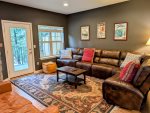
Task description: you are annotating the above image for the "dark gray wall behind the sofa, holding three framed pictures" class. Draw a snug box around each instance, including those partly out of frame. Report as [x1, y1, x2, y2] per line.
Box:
[68, 0, 150, 51]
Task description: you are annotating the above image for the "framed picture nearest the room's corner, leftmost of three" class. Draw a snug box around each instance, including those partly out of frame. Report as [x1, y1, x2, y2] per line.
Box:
[81, 26, 90, 40]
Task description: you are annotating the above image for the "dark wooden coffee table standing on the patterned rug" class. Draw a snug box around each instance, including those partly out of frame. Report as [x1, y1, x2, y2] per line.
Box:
[57, 66, 87, 89]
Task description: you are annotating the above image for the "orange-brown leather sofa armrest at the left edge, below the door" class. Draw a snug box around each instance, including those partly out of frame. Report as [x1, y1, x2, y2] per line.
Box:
[0, 82, 12, 94]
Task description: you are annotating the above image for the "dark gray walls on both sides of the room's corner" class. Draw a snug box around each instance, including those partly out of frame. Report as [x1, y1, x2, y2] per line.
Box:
[0, 0, 150, 78]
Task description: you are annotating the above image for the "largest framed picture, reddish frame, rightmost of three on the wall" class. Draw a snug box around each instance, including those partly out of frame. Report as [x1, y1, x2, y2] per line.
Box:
[114, 22, 128, 41]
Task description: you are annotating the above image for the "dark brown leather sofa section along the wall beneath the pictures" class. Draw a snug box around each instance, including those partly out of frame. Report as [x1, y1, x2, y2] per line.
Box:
[57, 48, 125, 79]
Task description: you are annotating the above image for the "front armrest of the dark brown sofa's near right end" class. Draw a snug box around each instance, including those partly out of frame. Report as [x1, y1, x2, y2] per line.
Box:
[102, 75, 144, 110]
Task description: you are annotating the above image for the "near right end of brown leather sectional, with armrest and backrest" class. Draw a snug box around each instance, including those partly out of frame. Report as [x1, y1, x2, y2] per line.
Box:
[102, 59, 150, 110]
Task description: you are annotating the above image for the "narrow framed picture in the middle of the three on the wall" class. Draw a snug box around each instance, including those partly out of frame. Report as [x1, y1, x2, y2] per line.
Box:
[97, 22, 106, 39]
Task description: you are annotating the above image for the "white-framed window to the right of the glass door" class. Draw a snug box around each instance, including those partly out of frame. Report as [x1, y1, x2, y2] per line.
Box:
[38, 25, 64, 58]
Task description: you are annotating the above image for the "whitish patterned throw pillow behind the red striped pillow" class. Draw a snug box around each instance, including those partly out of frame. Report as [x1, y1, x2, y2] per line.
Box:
[120, 53, 142, 68]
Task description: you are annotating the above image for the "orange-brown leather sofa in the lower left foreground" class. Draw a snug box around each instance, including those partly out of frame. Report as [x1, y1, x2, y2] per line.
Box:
[0, 82, 59, 113]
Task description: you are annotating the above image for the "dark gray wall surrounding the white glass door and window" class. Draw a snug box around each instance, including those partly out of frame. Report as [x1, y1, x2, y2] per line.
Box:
[0, 2, 67, 79]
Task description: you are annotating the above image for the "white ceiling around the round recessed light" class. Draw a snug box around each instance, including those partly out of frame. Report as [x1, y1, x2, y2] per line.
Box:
[0, 0, 128, 14]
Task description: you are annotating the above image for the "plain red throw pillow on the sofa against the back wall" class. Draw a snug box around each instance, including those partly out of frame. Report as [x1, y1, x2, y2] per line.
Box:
[82, 48, 95, 62]
